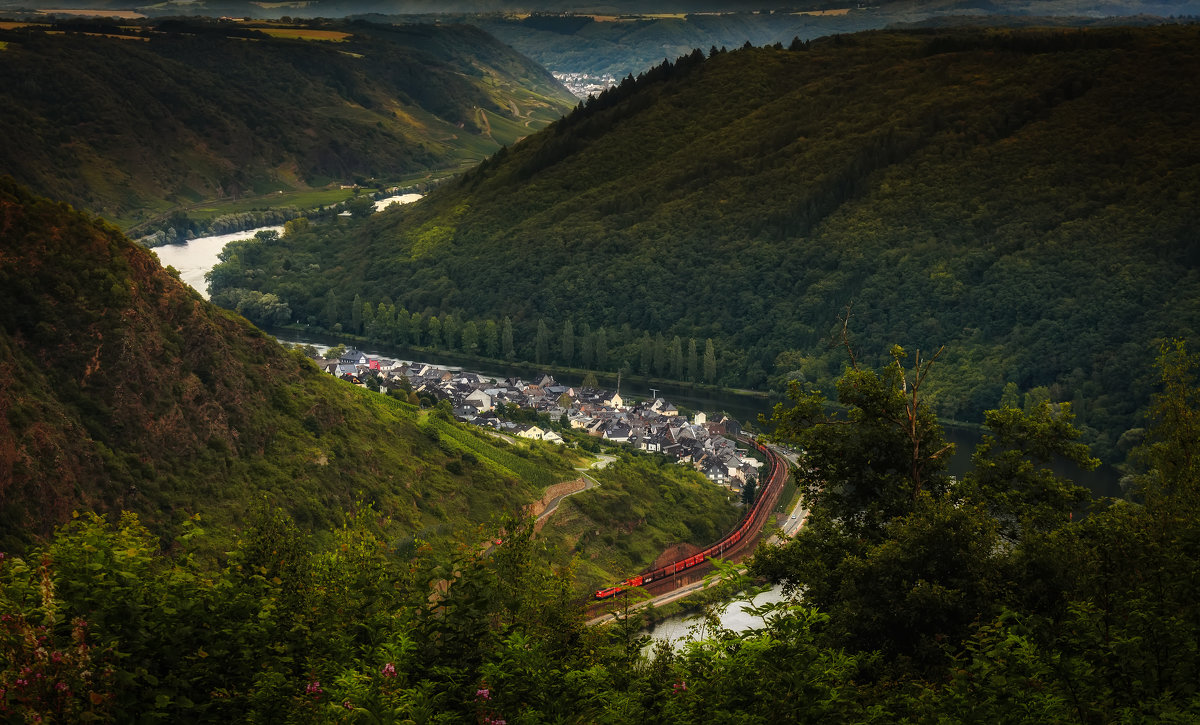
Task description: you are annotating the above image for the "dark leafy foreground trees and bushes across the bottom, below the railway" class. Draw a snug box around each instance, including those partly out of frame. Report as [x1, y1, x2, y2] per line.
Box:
[0, 343, 1200, 725]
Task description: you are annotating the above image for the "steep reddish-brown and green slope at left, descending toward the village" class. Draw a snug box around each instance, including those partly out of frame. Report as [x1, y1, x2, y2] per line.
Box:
[0, 179, 585, 550]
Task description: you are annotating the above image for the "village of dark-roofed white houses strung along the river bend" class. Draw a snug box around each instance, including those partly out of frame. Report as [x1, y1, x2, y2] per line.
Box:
[316, 348, 762, 493]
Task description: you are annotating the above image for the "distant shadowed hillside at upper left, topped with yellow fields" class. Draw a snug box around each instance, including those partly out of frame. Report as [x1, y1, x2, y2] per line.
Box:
[0, 19, 574, 222]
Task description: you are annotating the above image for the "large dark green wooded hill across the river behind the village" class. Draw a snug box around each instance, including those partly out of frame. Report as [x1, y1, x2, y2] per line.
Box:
[217, 26, 1200, 457]
